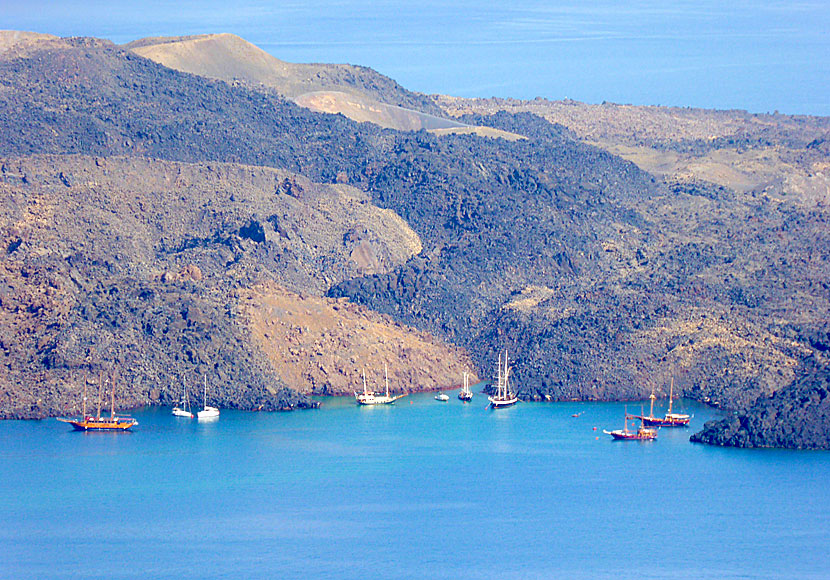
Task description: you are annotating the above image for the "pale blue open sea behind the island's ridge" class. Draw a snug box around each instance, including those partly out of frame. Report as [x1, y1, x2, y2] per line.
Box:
[8, 0, 830, 115]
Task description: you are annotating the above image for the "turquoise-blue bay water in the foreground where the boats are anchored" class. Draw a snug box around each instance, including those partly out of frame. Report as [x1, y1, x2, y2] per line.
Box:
[0, 392, 830, 580]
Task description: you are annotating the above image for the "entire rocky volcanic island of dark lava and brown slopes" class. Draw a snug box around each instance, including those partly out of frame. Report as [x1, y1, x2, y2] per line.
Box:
[0, 33, 830, 448]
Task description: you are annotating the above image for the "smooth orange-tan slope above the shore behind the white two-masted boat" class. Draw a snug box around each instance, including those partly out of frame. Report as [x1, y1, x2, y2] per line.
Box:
[239, 283, 476, 395]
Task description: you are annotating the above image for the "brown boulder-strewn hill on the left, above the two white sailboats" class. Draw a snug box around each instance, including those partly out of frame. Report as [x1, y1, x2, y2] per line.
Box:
[0, 155, 448, 417]
